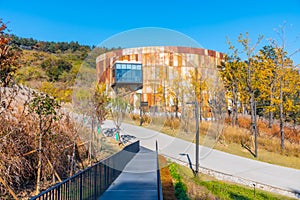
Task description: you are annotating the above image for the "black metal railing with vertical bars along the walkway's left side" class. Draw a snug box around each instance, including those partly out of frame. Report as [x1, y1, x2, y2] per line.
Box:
[31, 141, 140, 200]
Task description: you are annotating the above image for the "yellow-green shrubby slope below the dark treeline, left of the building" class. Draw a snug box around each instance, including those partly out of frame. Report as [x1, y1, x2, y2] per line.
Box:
[15, 50, 86, 102]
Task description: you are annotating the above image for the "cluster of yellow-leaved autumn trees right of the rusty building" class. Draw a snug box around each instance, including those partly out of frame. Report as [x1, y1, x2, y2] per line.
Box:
[219, 29, 300, 153]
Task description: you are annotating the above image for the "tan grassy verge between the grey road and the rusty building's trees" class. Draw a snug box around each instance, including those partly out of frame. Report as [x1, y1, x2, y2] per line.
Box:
[125, 115, 300, 169]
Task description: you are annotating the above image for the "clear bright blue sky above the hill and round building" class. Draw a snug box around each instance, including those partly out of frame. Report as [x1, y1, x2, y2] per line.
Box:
[0, 0, 300, 64]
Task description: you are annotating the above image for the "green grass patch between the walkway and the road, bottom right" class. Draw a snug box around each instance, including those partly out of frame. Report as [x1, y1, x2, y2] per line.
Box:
[164, 159, 298, 200]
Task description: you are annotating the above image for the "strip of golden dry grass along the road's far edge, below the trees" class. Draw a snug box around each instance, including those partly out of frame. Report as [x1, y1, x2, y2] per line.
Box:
[127, 113, 300, 169]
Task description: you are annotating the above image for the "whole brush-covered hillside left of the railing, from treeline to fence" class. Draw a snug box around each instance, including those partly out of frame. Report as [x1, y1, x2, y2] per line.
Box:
[0, 29, 120, 199]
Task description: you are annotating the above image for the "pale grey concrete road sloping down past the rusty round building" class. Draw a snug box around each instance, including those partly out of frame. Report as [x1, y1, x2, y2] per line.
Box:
[103, 121, 300, 198]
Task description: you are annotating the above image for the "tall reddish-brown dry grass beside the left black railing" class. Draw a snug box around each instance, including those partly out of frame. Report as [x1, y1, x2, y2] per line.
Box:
[0, 88, 118, 199]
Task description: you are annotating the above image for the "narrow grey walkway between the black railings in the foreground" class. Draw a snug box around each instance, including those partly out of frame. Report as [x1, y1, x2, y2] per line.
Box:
[100, 147, 158, 200]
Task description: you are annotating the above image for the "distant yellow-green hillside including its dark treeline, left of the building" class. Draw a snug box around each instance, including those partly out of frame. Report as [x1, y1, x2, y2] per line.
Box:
[7, 35, 117, 102]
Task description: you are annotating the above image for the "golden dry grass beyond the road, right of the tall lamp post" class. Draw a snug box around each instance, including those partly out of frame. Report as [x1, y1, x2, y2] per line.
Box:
[200, 124, 300, 169]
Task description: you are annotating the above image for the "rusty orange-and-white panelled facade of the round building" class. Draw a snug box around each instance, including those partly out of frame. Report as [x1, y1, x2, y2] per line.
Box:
[96, 46, 224, 115]
